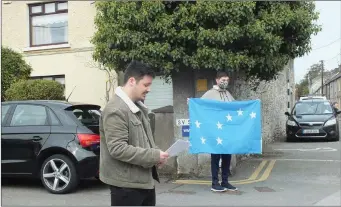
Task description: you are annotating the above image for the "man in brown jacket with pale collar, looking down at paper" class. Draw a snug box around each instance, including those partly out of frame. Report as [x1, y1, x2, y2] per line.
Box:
[100, 61, 168, 206]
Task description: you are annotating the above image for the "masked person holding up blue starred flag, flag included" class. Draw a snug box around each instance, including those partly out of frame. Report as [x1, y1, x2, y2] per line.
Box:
[188, 72, 262, 192]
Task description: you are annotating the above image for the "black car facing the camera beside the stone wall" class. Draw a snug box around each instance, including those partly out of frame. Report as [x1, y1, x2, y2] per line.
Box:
[285, 99, 341, 141]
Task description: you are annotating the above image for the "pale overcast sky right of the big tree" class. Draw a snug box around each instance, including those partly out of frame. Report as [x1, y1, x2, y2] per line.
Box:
[294, 1, 341, 83]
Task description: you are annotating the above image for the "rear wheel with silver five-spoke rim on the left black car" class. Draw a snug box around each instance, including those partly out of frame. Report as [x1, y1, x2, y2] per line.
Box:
[40, 154, 79, 194]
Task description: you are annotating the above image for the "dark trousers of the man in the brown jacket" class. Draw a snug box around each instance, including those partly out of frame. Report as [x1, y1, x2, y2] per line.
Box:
[110, 186, 156, 206]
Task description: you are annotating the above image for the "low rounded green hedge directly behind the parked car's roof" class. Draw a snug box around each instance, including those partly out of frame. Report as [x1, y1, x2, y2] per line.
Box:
[6, 80, 65, 101]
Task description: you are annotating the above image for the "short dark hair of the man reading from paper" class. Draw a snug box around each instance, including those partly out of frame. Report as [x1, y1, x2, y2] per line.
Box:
[124, 60, 155, 84]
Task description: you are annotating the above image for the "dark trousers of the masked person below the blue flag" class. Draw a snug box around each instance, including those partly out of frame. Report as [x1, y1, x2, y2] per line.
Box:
[211, 154, 231, 185]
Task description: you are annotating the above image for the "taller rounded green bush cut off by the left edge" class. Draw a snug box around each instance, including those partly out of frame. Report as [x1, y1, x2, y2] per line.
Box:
[1, 46, 32, 101]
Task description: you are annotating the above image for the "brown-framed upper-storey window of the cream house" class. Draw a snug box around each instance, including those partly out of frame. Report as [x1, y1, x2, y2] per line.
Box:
[29, 2, 68, 47]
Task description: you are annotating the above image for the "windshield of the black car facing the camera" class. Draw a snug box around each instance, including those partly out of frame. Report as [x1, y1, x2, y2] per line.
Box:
[293, 102, 333, 115]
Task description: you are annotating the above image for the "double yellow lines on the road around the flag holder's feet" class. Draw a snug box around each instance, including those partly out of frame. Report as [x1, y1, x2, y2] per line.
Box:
[173, 160, 276, 185]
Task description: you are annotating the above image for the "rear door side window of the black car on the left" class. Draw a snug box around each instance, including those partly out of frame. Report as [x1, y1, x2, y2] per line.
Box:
[10, 105, 48, 126]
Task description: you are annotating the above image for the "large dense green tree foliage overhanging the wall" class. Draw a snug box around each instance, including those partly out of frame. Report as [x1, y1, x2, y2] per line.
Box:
[92, 1, 320, 80]
